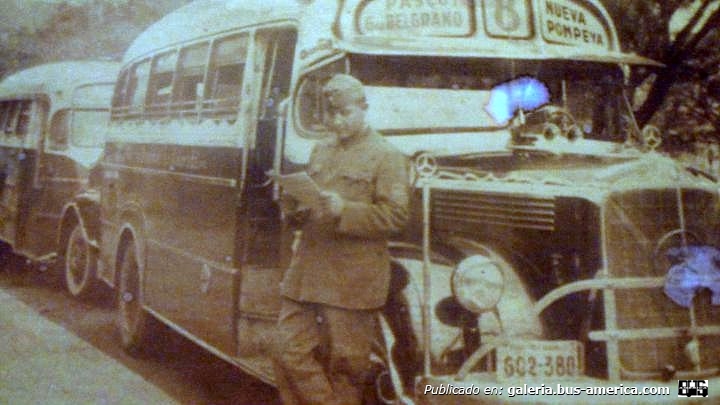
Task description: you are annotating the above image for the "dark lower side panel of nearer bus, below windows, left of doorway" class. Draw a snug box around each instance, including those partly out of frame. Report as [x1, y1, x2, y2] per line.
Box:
[103, 142, 242, 352]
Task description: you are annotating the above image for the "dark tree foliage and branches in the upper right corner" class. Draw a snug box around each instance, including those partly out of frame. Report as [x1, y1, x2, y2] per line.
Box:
[607, 0, 720, 148]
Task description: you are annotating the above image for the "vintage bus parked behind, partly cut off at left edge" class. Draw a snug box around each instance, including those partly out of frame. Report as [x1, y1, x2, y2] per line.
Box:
[0, 61, 120, 296]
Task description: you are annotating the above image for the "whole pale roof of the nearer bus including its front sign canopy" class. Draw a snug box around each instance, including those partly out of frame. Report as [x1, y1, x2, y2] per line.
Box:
[123, 0, 660, 65]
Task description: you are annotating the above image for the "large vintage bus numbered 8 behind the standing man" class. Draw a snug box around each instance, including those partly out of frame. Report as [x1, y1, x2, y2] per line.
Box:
[100, 0, 720, 403]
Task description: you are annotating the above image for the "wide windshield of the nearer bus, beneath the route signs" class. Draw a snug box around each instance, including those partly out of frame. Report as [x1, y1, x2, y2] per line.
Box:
[292, 55, 629, 142]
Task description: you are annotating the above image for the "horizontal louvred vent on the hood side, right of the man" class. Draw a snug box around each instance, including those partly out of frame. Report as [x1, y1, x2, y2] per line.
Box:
[432, 190, 555, 231]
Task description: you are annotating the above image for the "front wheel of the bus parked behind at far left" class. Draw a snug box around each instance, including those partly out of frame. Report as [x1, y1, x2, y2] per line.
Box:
[63, 224, 98, 298]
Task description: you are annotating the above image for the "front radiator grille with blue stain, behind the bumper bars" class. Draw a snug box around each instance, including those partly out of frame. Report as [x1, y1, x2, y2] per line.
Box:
[606, 190, 720, 372]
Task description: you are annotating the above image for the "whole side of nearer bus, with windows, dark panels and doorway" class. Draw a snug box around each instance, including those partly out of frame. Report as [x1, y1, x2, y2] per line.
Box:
[100, 16, 296, 370]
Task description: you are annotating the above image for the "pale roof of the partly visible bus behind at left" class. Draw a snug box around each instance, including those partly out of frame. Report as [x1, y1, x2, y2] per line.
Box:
[0, 61, 120, 98]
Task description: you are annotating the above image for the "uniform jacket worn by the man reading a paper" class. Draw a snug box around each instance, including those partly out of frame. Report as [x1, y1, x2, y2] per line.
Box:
[281, 129, 408, 309]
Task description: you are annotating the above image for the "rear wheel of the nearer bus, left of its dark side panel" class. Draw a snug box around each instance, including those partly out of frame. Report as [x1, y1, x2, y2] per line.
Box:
[117, 243, 153, 355]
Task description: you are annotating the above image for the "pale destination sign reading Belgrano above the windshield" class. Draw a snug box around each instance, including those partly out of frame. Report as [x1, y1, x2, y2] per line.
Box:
[356, 0, 475, 37]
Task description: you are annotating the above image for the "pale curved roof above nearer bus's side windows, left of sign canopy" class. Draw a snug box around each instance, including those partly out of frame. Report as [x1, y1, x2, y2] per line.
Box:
[123, 0, 302, 63]
